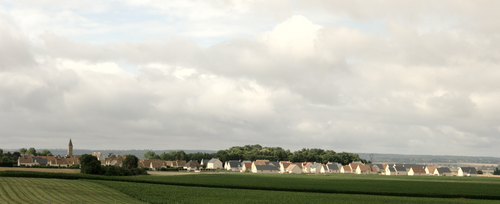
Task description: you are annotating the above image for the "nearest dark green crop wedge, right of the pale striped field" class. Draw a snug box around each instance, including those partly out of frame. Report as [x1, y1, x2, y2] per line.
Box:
[92, 180, 499, 204]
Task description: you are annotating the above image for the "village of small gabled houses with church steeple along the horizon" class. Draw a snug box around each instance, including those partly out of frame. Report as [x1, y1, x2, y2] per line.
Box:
[15, 140, 477, 176]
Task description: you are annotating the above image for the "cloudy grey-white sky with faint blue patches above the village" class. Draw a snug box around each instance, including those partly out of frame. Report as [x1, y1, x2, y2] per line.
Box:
[0, 0, 500, 157]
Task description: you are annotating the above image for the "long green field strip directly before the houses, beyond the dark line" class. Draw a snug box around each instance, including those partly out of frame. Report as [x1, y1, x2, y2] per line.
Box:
[102, 174, 500, 200]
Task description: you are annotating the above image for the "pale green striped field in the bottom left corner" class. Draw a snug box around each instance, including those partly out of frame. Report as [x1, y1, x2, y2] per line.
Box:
[0, 177, 144, 204]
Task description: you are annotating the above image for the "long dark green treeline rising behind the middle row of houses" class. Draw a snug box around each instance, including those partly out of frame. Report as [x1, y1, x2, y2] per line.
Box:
[144, 144, 367, 165]
